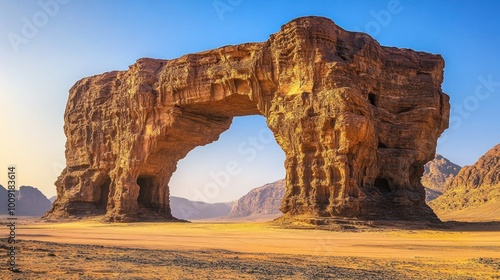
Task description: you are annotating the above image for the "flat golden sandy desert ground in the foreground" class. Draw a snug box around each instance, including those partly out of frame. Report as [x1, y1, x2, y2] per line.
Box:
[0, 221, 500, 279]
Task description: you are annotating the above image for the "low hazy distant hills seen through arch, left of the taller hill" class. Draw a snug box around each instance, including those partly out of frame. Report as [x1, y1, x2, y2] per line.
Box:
[170, 196, 233, 220]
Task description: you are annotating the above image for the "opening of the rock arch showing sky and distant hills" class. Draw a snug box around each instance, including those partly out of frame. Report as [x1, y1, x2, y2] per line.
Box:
[169, 115, 285, 220]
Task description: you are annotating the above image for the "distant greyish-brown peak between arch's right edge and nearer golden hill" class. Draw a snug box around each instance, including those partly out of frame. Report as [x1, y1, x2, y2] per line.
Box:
[420, 154, 461, 201]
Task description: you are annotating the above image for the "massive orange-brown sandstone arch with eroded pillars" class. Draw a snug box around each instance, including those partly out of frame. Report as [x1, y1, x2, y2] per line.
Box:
[47, 17, 449, 221]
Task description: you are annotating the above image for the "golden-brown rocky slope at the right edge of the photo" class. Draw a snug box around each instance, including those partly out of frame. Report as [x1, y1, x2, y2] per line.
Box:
[430, 145, 500, 220]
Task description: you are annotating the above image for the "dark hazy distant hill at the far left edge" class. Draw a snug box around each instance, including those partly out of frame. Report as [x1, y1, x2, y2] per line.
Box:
[0, 185, 52, 216]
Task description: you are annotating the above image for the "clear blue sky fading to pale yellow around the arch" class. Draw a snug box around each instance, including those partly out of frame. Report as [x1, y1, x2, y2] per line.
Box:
[0, 0, 500, 202]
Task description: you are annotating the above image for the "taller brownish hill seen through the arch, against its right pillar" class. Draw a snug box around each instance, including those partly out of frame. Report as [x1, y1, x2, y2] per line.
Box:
[227, 180, 285, 218]
